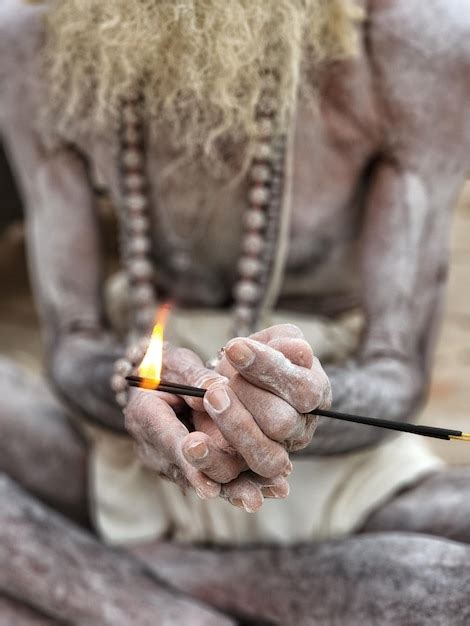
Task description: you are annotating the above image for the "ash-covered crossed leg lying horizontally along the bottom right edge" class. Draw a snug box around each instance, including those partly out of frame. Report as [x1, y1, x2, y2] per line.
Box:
[134, 533, 470, 626]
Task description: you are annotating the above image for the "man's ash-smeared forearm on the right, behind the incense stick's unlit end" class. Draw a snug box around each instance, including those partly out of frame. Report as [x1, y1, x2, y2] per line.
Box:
[309, 161, 452, 454]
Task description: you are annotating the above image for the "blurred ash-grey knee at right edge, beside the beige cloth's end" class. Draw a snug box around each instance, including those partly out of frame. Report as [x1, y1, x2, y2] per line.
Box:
[361, 467, 470, 544]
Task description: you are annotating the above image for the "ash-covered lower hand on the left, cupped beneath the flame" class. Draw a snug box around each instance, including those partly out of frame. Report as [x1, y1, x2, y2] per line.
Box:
[124, 343, 252, 499]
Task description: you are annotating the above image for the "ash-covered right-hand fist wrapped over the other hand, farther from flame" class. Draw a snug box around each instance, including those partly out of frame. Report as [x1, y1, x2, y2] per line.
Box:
[198, 324, 331, 492]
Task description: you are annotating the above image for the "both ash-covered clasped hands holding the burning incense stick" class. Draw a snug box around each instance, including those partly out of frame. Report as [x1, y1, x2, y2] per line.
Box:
[125, 324, 331, 512]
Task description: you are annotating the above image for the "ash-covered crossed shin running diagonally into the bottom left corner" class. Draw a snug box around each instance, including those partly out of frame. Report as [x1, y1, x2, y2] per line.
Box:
[0, 476, 233, 626]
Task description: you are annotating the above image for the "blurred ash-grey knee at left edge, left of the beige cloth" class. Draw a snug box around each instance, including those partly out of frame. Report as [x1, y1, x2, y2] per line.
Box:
[0, 358, 87, 521]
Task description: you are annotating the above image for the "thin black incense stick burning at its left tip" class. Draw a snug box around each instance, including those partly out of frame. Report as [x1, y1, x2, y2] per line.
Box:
[126, 376, 470, 441]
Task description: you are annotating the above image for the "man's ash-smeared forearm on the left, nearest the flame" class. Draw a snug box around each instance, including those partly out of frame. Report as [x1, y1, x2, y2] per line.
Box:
[2, 122, 124, 430]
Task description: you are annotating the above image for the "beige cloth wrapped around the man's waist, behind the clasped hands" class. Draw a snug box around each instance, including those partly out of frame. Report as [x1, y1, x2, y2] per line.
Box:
[81, 311, 442, 545]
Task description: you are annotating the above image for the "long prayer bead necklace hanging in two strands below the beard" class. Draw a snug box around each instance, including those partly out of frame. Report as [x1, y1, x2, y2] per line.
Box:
[119, 77, 286, 346]
